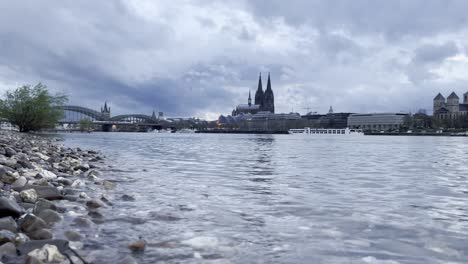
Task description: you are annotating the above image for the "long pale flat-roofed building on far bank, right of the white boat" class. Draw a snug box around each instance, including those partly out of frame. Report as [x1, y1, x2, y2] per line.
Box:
[348, 113, 408, 131]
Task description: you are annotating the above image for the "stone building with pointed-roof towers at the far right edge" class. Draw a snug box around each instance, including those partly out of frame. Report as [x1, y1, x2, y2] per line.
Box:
[433, 92, 468, 119]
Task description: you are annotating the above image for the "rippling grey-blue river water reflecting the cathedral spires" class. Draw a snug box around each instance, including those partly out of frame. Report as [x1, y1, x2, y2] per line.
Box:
[59, 133, 468, 264]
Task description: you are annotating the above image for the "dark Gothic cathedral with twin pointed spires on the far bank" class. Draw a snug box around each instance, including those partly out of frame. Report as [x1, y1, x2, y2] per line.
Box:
[232, 73, 275, 116]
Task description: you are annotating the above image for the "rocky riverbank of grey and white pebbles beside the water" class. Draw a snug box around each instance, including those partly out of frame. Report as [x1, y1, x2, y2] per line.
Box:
[0, 131, 133, 264]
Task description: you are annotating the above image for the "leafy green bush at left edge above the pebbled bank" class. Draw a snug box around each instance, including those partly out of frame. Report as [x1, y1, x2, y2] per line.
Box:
[0, 83, 67, 132]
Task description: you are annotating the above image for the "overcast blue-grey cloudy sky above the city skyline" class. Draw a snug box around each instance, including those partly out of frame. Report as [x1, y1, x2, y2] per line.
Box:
[0, 0, 468, 119]
